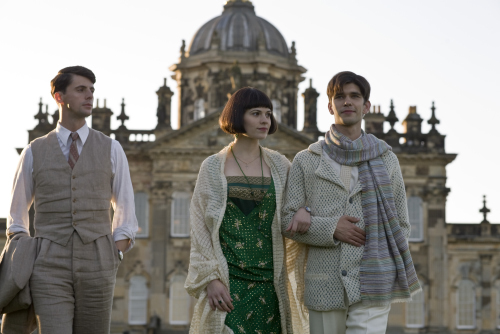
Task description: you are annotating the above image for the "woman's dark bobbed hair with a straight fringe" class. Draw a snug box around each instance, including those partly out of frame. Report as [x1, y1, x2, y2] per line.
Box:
[219, 87, 278, 135]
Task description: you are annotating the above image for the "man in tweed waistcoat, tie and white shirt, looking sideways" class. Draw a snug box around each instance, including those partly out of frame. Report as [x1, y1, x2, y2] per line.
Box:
[7, 66, 137, 334]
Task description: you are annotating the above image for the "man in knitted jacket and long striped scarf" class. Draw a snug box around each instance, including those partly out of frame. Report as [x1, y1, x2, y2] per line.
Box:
[282, 72, 421, 334]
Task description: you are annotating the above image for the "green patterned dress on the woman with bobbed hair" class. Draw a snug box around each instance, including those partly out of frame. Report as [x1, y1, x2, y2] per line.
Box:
[219, 176, 281, 334]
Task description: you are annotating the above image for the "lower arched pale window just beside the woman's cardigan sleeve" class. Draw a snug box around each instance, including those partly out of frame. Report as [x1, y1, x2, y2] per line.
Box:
[169, 275, 191, 325]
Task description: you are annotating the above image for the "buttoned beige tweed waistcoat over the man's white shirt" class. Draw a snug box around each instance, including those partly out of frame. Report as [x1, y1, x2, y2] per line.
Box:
[31, 129, 113, 246]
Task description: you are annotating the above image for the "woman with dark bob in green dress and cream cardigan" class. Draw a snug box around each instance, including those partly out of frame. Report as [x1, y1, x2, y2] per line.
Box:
[185, 87, 308, 334]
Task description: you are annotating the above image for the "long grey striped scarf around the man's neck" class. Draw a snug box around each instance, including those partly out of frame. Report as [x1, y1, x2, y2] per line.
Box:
[322, 125, 421, 305]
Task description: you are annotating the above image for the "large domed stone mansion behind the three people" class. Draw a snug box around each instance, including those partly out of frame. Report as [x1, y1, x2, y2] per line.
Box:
[5, 0, 500, 334]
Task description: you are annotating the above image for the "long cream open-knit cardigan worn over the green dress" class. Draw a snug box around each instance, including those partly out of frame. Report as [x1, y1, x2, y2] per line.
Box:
[185, 146, 309, 334]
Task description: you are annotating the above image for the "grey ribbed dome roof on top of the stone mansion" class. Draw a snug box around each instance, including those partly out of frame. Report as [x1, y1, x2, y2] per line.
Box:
[189, 0, 288, 58]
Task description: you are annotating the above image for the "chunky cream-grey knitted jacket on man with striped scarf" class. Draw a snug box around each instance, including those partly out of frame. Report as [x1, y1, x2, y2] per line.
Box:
[282, 142, 410, 311]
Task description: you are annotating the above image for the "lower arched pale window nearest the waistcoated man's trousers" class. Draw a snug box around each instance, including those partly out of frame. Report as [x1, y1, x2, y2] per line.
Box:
[128, 276, 148, 325]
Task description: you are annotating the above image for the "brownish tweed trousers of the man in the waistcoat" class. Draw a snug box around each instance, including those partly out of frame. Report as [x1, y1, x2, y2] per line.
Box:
[30, 232, 120, 334]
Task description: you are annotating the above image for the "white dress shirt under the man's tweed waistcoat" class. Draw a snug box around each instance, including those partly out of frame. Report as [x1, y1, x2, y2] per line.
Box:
[7, 123, 138, 251]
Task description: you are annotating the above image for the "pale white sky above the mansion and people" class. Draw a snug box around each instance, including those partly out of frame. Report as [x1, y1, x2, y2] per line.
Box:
[0, 0, 500, 223]
